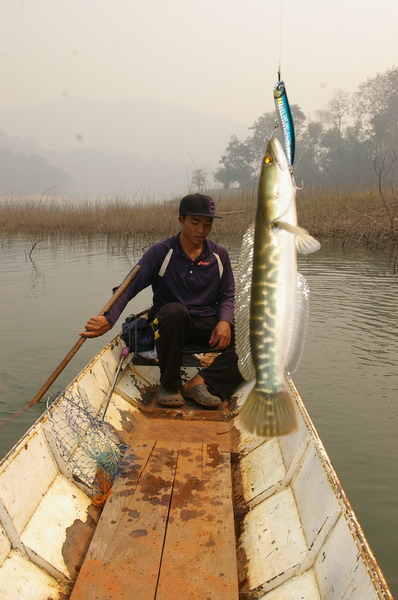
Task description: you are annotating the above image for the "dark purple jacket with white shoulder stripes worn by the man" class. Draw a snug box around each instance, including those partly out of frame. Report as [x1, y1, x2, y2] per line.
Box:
[106, 234, 235, 327]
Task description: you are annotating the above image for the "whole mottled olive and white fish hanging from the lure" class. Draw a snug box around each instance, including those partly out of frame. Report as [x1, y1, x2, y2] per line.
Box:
[235, 136, 320, 437]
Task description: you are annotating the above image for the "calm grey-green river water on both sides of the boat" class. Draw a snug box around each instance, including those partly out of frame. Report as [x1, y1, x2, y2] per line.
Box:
[0, 232, 398, 593]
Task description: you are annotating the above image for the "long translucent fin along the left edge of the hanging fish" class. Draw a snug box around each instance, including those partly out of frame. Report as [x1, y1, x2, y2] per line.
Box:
[235, 223, 256, 381]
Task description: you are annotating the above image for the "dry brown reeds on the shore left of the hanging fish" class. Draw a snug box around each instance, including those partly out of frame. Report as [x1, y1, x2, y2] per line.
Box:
[0, 190, 254, 238]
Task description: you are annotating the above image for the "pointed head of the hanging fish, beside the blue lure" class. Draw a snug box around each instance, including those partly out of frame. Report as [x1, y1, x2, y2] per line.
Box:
[257, 137, 294, 225]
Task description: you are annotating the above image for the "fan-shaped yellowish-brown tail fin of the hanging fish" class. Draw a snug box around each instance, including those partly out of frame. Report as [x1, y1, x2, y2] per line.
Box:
[239, 387, 296, 437]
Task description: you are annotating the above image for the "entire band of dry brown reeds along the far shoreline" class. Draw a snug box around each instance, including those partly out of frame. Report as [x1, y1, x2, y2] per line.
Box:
[0, 188, 398, 252]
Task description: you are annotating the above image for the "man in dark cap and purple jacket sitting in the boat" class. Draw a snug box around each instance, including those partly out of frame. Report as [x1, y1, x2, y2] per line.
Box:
[80, 194, 242, 407]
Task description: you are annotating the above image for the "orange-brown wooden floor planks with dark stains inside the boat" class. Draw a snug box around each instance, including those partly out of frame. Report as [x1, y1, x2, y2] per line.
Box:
[71, 441, 238, 600]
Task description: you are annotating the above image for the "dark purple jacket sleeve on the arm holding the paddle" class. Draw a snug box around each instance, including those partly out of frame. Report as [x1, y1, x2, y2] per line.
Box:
[105, 242, 164, 327]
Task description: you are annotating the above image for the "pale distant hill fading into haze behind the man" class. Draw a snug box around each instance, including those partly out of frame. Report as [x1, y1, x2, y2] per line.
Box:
[0, 97, 247, 195]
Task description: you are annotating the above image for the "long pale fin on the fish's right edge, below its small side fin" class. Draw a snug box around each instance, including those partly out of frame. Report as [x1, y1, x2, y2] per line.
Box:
[286, 273, 310, 373]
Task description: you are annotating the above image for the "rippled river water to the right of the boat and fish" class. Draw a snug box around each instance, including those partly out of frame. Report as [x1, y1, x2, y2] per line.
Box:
[294, 247, 398, 594]
